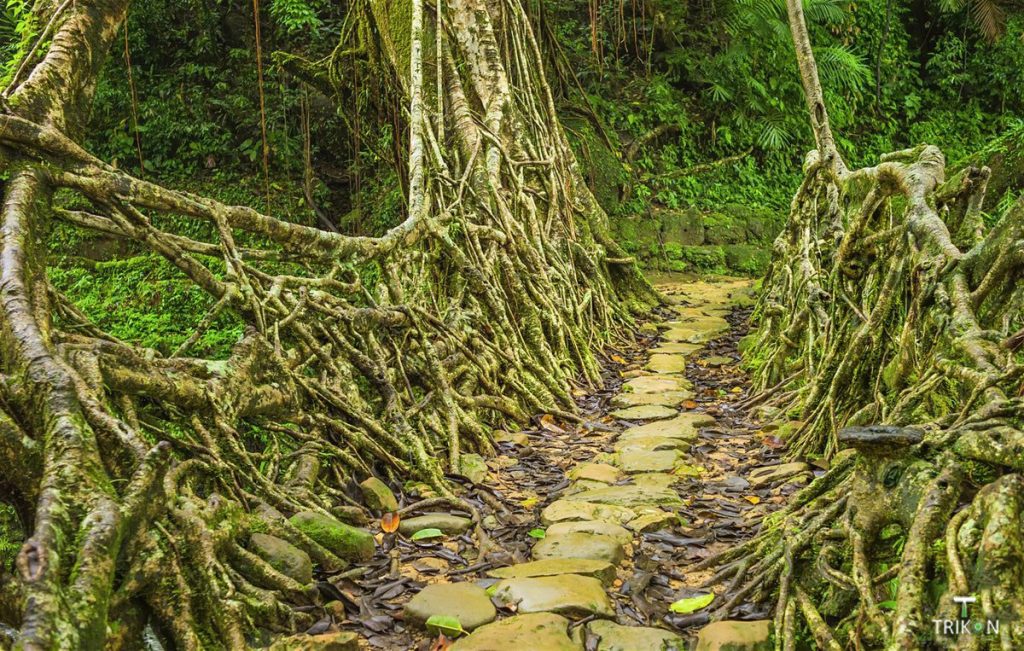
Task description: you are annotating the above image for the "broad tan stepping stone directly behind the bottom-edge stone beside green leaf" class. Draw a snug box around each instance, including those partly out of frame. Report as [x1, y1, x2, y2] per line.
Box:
[493, 574, 615, 618]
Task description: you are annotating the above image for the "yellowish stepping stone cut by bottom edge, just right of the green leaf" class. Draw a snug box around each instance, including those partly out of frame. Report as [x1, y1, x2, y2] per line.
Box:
[451, 612, 583, 651]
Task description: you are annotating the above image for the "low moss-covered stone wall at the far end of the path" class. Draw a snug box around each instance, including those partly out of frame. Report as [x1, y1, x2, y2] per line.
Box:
[612, 204, 785, 275]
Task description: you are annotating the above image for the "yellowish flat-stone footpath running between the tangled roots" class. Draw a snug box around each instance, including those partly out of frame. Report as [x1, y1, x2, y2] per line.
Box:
[406, 280, 768, 651]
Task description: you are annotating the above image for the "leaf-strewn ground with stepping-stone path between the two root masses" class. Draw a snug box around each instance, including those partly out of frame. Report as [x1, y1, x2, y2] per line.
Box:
[301, 275, 820, 651]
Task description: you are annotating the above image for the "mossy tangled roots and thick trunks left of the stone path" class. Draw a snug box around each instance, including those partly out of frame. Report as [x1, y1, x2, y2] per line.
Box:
[0, 0, 655, 649]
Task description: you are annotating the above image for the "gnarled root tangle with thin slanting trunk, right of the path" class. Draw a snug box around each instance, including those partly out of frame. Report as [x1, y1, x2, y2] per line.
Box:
[702, 2, 1024, 649]
